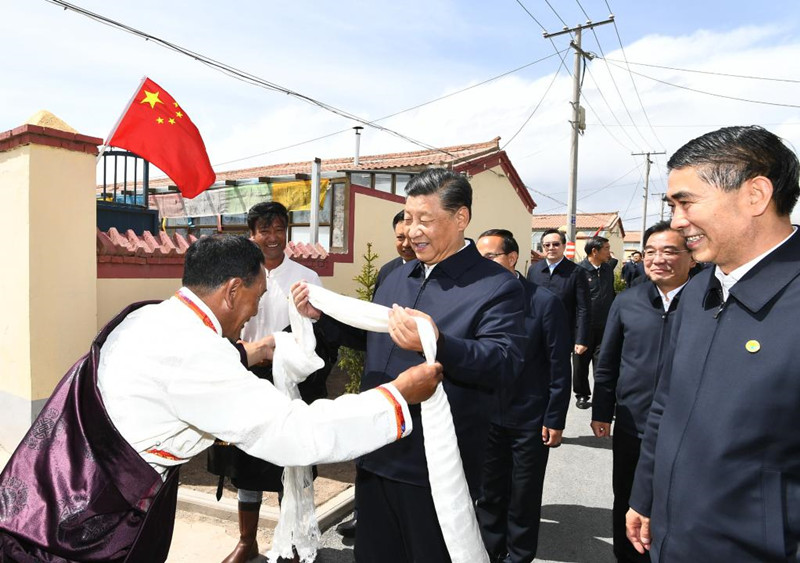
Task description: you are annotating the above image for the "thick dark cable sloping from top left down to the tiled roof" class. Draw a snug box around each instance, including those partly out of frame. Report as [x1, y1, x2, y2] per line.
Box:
[46, 0, 456, 158]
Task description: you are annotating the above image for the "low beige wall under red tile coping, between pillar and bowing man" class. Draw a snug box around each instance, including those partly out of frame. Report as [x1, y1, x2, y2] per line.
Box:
[97, 278, 181, 330]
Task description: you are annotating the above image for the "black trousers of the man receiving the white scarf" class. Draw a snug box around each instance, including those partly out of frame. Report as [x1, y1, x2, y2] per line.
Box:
[355, 468, 450, 563]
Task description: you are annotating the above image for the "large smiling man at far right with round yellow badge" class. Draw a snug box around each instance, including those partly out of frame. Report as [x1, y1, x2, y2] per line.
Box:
[627, 126, 800, 563]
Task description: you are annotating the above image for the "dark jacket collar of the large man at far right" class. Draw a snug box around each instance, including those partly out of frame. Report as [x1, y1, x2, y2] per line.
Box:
[703, 229, 800, 313]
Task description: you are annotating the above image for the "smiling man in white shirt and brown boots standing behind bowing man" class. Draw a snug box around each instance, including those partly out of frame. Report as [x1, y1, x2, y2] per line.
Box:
[217, 201, 336, 563]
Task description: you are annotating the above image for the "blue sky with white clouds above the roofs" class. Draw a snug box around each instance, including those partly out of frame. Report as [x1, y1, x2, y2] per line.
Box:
[0, 0, 800, 230]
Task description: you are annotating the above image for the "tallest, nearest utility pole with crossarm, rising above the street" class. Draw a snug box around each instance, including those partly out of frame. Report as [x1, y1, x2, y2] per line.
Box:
[542, 15, 614, 242]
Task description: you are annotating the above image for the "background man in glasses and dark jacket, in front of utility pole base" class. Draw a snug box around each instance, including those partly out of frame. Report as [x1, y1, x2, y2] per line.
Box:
[528, 229, 590, 408]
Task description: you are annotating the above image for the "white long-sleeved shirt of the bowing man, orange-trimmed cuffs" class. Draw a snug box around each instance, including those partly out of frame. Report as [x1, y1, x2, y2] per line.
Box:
[97, 288, 412, 478]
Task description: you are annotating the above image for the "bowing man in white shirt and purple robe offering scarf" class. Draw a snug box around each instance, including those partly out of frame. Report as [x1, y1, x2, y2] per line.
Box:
[0, 235, 441, 561]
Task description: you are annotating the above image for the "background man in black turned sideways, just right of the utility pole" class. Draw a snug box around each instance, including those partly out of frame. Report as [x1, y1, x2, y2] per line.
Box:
[572, 236, 617, 409]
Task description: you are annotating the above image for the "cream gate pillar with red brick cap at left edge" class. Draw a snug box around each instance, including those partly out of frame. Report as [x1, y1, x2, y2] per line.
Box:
[0, 119, 102, 452]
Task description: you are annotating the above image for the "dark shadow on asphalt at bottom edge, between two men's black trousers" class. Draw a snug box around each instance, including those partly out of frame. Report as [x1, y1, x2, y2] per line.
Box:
[536, 504, 615, 563]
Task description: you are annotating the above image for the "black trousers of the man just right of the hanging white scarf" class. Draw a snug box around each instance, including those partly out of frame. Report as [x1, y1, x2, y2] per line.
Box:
[476, 424, 550, 563]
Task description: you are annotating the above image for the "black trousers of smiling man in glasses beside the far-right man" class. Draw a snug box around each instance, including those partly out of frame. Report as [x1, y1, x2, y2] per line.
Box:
[611, 427, 650, 563]
